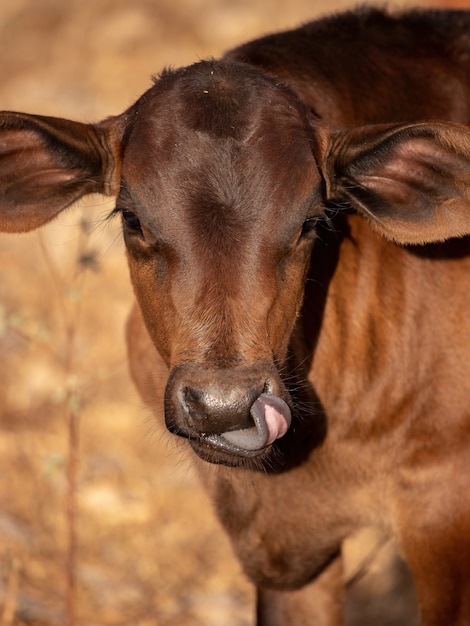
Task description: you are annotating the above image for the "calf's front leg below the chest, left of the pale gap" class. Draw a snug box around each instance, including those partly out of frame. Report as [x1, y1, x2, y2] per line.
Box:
[257, 558, 343, 626]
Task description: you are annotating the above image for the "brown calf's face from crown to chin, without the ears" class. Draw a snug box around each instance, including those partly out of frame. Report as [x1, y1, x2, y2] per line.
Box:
[117, 64, 323, 460]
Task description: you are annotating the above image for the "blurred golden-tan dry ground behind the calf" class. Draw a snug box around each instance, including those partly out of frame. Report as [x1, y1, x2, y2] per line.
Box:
[0, 0, 462, 626]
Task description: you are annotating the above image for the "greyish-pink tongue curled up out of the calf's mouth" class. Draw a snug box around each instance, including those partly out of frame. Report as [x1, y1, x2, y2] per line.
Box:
[221, 393, 291, 450]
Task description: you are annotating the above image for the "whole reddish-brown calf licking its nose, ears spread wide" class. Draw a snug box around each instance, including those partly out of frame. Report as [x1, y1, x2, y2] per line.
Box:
[0, 9, 470, 626]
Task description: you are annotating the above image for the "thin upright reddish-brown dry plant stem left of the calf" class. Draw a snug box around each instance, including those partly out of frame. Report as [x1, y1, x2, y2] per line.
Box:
[38, 233, 85, 626]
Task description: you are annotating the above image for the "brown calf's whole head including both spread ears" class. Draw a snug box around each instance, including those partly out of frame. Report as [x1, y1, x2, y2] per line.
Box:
[0, 61, 470, 464]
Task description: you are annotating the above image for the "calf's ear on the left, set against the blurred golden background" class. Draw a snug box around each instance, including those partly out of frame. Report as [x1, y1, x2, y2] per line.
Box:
[0, 112, 123, 232]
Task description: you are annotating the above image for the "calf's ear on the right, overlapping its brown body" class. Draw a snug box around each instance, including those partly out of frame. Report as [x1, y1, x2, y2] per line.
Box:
[323, 123, 470, 244]
